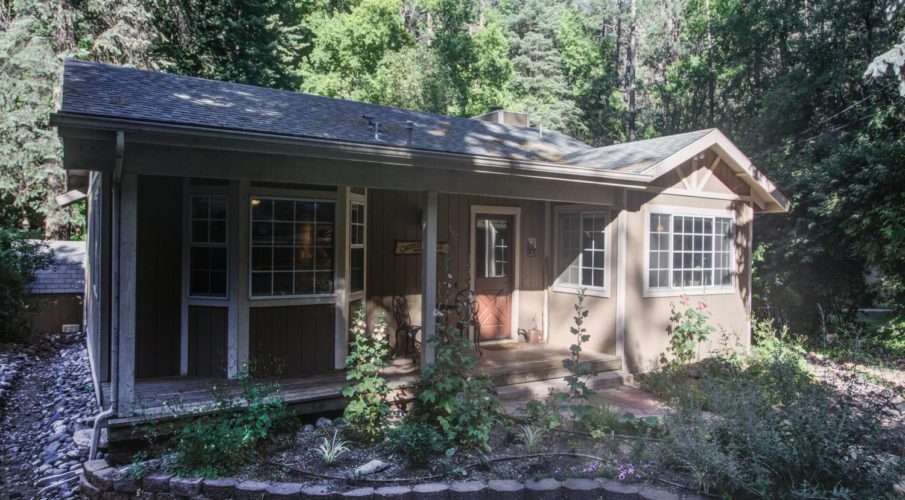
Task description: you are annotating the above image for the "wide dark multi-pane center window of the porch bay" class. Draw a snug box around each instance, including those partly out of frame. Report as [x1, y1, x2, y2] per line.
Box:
[251, 198, 336, 297]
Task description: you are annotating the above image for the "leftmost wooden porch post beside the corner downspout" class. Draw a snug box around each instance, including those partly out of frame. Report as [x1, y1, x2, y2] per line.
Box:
[113, 174, 138, 416]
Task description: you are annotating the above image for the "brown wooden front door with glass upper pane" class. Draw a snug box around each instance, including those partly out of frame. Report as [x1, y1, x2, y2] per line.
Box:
[474, 214, 516, 340]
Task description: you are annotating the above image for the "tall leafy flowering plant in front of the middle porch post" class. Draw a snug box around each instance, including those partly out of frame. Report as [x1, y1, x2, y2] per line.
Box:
[406, 263, 499, 453]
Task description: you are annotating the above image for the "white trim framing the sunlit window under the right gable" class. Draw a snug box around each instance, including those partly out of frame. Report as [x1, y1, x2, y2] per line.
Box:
[642, 205, 750, 298]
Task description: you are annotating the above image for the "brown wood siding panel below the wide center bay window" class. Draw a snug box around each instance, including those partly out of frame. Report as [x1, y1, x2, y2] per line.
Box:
[248, 304, 336, 375]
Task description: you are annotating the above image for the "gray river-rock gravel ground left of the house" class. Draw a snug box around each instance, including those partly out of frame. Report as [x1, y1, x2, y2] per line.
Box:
[0, 333, 98, 498]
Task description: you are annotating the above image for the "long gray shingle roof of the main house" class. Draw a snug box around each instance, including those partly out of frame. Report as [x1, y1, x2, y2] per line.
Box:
[61, 60, 707, 172]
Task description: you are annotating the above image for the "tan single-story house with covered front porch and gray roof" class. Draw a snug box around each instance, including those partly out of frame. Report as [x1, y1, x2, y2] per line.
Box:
[52, 60, 788, 446]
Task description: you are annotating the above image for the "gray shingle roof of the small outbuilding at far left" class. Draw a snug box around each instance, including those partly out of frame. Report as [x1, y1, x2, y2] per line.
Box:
[27, 241, 85, 295]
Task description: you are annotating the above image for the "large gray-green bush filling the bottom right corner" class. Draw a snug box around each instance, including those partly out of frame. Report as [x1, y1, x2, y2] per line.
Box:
[662, 328, 905, 498]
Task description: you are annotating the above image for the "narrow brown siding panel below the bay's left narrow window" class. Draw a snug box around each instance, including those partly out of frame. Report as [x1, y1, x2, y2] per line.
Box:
[188, 306, 229, 378]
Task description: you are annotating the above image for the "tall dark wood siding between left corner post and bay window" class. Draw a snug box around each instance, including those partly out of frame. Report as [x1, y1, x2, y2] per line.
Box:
[135, 175, 182, 378]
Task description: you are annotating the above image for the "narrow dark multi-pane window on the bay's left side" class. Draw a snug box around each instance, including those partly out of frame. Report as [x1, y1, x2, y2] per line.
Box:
[189, 194, 229, 298]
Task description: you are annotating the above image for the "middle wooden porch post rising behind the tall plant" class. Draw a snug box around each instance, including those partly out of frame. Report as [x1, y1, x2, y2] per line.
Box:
[421, 191, 437, 366]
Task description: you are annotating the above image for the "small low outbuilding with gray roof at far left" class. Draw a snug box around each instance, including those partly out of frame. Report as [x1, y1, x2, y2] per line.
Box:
[25, 240, 85, 333]
